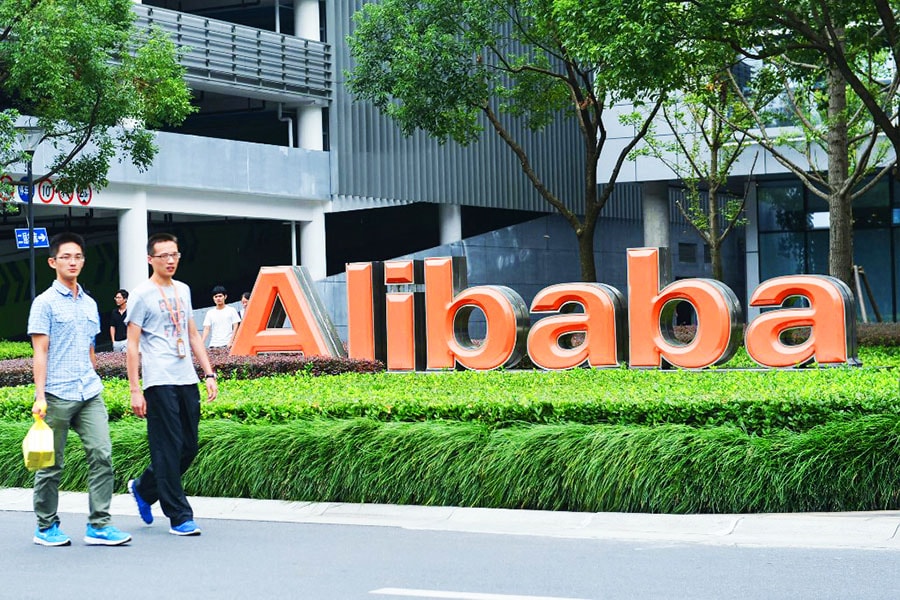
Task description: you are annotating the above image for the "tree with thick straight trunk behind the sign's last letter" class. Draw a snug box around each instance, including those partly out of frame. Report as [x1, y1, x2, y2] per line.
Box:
[732, 32, 894, 289]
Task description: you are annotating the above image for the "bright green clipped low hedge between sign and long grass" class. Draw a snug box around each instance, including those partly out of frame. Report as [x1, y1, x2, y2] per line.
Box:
[0, 358, 900, 433]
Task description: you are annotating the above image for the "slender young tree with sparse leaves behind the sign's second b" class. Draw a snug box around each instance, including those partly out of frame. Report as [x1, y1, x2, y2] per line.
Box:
[633, 70, 756, 280]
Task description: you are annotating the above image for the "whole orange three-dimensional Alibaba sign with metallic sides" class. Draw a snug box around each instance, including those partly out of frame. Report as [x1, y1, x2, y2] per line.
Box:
[231, 248, 858, 371]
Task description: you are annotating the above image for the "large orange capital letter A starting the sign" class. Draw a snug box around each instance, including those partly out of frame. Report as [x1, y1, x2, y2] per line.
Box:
[231, 267, 345, 357]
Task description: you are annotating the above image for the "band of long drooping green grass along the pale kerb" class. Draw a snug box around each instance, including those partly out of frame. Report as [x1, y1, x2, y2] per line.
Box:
[0, 415, 900, 513]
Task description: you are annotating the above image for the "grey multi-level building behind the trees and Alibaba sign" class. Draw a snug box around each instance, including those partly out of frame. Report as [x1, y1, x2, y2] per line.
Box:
[7, 0, 888, 342]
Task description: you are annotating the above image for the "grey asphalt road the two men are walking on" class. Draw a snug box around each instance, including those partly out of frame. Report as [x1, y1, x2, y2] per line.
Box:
[0, 511, 900, 600]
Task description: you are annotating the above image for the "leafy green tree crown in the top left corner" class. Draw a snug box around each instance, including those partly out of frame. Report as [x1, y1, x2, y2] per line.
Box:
[0, 0, 193, 196]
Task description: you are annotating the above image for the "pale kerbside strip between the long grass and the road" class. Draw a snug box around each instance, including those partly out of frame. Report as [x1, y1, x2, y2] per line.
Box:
[0, 488, 900, 550]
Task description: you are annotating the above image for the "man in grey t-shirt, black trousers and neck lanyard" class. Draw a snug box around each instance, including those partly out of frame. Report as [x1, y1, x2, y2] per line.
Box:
[126, 233, 219, 535]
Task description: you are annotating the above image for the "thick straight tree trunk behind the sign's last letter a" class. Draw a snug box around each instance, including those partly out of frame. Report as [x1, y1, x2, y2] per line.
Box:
[827, 59, 853, 289]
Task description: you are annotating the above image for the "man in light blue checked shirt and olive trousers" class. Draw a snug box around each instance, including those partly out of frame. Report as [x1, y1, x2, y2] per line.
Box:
[28, 233, 131, 546]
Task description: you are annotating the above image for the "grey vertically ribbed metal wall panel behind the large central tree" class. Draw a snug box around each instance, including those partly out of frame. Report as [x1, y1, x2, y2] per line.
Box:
[328, 0, 584, 212]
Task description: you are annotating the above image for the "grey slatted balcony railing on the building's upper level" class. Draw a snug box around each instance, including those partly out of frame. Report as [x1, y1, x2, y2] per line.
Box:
[134, 4, 331, 105]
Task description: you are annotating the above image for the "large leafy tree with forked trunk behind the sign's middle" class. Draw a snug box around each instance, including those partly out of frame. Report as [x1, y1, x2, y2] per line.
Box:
[347, 0, 674, 281]
